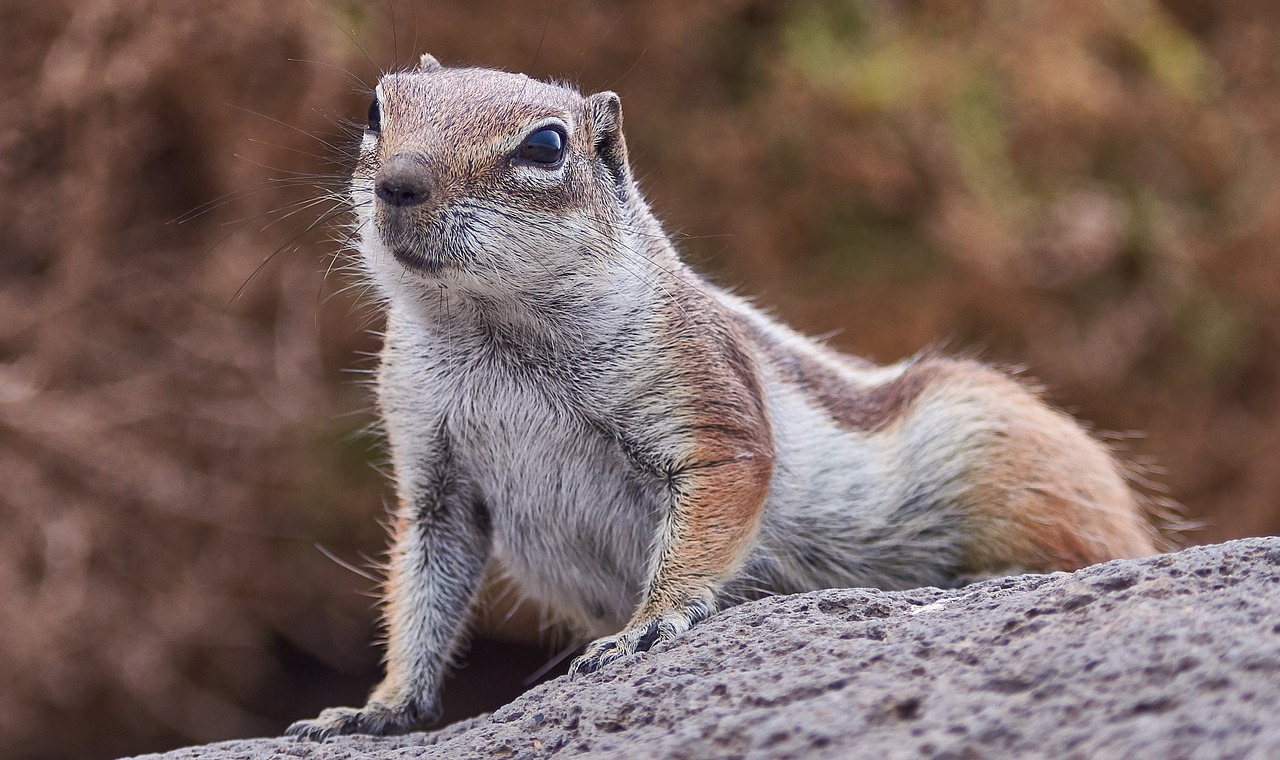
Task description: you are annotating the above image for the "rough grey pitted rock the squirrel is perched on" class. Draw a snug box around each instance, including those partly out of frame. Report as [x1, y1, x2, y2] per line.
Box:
[129, 539, 1280, 760]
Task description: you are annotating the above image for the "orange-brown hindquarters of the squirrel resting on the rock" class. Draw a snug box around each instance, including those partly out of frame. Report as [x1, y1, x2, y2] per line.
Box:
[913, 365, 1160, 576]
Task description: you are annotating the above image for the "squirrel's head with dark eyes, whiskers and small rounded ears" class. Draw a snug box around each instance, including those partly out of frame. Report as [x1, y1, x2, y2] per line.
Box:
[351, 55, 643, 290]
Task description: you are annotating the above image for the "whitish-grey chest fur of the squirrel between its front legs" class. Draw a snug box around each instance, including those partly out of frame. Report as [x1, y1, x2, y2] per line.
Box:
[379, 301, 659, 635]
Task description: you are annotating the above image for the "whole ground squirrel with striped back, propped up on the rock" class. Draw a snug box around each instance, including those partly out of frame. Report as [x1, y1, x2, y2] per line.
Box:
[289, 56, 1156, 738]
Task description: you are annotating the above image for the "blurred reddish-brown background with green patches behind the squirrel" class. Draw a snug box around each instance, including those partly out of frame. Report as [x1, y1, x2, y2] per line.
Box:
[0, 0, 1280, 759]
